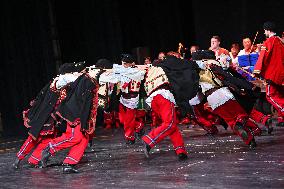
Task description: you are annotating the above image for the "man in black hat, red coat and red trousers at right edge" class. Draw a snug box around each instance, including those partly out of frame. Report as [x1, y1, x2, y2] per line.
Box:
[254, 22, 284, 125]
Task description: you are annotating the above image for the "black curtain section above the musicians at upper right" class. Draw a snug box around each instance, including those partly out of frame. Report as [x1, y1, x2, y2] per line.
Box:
[192, 0, 284, 50]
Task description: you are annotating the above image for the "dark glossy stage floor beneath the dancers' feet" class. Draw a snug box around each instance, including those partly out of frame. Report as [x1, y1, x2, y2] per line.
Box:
[0, 125, 284, 189]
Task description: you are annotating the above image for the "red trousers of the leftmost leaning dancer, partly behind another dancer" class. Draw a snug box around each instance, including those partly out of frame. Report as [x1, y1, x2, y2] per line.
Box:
[17, 136, 52, 165]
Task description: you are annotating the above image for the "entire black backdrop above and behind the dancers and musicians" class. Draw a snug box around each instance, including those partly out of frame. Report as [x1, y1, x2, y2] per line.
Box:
[0, 0, 284, 136]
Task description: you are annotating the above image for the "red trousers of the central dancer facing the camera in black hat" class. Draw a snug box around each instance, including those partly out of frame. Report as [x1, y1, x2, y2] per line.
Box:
[119, 104, 144, 140]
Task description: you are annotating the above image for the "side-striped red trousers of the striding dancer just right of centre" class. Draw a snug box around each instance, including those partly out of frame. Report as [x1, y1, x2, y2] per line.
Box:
[142, 95, 187, 154]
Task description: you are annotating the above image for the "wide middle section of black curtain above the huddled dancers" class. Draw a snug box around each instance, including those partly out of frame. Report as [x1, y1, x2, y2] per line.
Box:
[55, 0, 194, 65]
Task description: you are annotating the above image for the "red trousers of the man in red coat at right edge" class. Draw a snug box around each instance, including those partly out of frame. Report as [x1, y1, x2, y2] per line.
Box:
[266, 84, 284, 117]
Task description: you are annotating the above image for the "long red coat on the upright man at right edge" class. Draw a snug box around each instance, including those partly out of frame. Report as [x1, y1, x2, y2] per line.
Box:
[254, 36, 284, 85]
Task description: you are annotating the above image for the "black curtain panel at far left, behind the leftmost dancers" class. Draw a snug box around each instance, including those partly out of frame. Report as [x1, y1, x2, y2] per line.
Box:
[0, 0, 56, 136]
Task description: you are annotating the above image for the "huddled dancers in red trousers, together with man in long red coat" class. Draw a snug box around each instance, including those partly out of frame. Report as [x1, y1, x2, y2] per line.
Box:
[13, 22, 284, 173]
